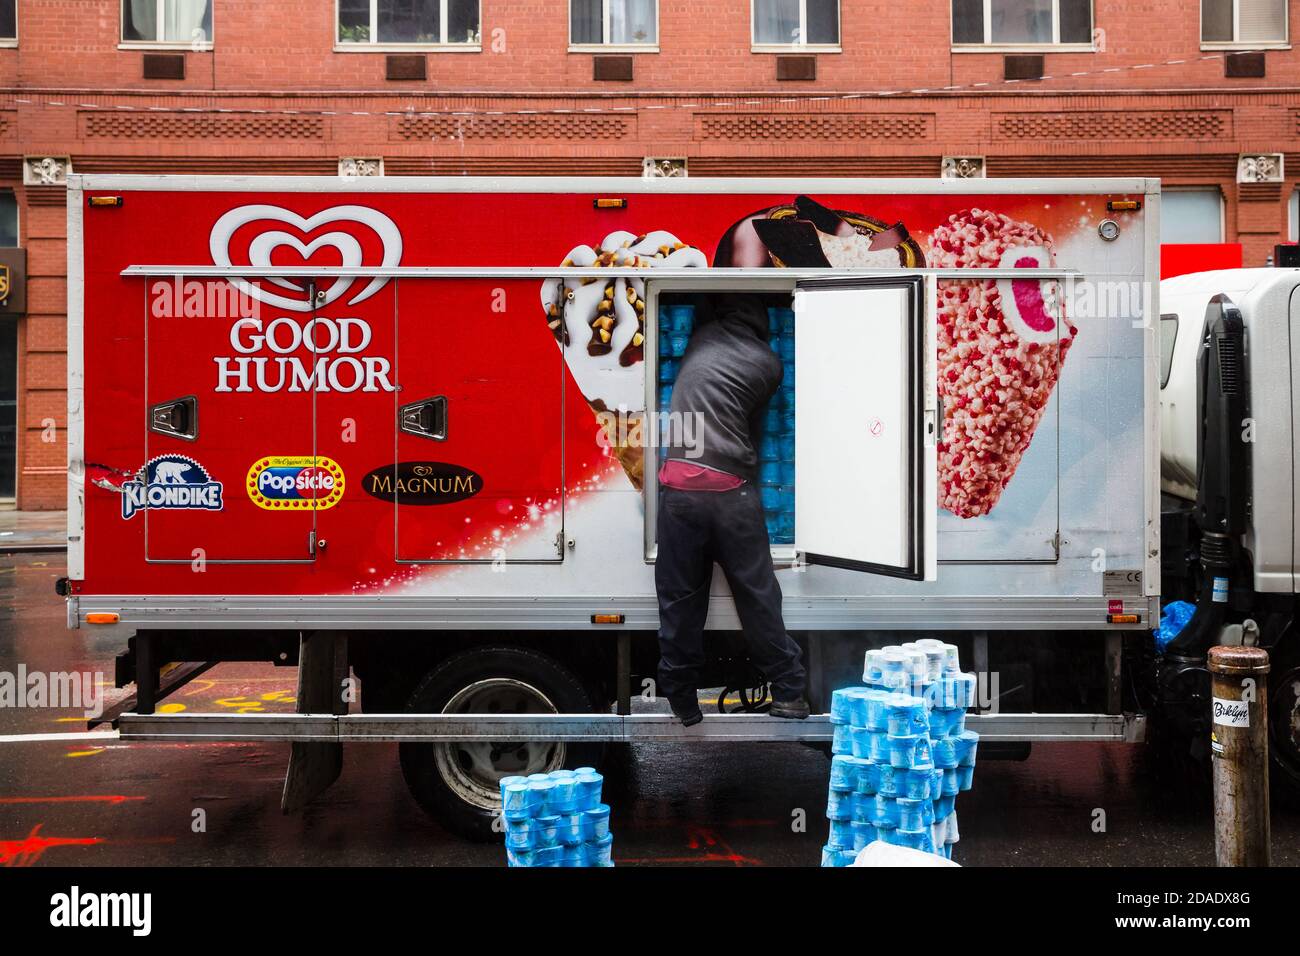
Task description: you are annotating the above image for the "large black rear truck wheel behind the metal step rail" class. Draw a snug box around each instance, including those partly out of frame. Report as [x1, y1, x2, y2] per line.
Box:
[399, 646, 602, 842]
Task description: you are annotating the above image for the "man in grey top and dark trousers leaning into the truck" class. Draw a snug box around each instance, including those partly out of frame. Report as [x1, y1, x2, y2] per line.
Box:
[654, 294, 809, 727]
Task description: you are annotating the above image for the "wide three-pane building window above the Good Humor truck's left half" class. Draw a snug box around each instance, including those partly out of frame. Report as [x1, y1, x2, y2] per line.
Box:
[338, 0, 480, 47]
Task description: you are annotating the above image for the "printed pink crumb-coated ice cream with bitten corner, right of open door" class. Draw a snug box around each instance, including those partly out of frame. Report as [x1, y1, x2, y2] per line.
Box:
[927, 209, 1078, 518]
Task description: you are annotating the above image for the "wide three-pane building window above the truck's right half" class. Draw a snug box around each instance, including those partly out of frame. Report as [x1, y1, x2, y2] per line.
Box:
[953, 0, 1092, 47]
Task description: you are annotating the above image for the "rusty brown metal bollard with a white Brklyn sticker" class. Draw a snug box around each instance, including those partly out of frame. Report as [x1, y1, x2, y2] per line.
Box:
[1208, 646, 1270, 866]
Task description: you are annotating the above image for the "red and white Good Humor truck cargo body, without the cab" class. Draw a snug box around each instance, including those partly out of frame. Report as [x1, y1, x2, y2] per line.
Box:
[60, 176, 1180, 835]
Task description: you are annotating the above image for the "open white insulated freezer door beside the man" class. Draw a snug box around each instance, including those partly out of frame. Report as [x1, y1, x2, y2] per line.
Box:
[794, 276, 940, 581]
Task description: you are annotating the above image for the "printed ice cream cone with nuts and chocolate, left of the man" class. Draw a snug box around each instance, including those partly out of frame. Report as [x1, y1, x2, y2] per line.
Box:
[542, 230, 709, 489]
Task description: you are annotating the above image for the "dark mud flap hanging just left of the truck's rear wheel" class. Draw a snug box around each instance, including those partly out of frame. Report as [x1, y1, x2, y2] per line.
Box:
[280, 631, 347, 813]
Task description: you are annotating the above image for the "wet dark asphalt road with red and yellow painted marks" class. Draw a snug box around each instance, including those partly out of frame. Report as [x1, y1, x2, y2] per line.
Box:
[0, 554, 1300, 866]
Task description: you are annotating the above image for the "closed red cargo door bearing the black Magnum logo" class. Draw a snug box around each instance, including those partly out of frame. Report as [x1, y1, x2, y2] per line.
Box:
[390, 278, 564, 567]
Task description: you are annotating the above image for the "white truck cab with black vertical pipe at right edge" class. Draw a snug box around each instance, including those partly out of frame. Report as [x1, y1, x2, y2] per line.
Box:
[1157, 268, 1300, 793]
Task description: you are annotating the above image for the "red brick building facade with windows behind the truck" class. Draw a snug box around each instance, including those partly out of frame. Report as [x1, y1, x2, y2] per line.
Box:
[0, 0, 1300, 509]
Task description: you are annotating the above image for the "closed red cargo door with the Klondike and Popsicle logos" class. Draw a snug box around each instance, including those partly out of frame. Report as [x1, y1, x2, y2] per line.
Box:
[142, 276, 319, 563]
